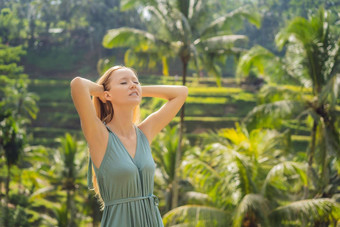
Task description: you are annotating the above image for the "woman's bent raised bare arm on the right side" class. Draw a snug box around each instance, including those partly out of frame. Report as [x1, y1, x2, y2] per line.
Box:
[139, 85, 188, 143]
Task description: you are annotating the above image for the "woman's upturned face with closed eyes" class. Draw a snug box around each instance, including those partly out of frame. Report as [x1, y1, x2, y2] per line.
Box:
[106, 69, 142, 106]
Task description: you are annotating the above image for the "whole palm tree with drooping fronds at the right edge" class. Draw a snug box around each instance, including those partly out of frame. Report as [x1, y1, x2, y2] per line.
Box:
[238, 8, 340, 198]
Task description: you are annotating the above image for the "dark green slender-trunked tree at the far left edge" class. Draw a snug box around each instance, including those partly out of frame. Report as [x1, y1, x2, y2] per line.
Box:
[0, 57, 38, 226]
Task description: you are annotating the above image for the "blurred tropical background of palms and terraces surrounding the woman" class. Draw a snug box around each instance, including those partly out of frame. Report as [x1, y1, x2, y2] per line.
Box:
[0, 0, 340, 227]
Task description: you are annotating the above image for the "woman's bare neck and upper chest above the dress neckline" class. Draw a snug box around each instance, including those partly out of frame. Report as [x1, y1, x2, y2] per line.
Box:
[107, 107, 135, 137]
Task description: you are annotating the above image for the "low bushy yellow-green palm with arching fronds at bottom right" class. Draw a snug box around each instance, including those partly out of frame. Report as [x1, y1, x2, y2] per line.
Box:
[163, 125, 340, 227]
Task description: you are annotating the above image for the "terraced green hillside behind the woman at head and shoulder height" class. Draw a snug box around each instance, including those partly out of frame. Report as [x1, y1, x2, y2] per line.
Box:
[29, 76, 308, 150]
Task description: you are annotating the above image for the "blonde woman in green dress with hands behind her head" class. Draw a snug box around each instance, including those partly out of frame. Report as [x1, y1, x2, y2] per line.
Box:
[71, 66, 188, 227]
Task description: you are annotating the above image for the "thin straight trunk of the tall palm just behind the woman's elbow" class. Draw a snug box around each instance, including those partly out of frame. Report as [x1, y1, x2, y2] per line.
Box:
[171, 57, 189, 209]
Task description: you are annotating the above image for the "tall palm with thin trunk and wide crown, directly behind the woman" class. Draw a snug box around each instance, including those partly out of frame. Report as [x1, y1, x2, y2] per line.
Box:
[103, 0, 260, 207]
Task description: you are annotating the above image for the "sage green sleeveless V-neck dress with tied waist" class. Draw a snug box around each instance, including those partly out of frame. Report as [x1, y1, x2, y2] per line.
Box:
[87, 123, 163, 227]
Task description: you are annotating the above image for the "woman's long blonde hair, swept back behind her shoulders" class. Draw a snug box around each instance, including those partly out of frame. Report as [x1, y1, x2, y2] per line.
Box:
[89, 66, 140, 209]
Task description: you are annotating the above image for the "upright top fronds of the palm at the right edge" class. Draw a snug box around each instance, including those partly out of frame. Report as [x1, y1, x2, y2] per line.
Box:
[276, 7, 339, 92]
